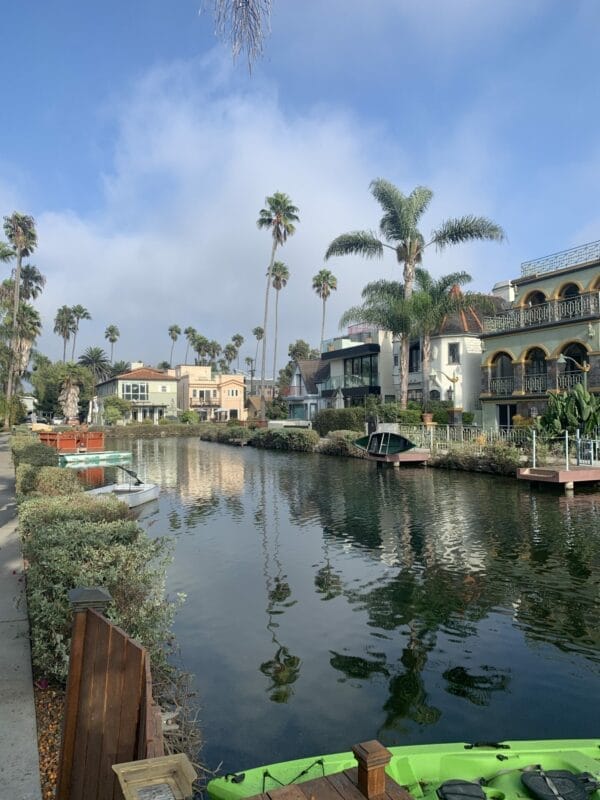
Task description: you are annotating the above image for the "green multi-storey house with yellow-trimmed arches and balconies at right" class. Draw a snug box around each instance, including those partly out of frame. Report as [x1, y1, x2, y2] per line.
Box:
[480, 241, 600, 429]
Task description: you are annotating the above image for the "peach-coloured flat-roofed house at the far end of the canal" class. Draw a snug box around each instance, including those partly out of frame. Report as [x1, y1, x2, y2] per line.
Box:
[176, 364, 246, 422]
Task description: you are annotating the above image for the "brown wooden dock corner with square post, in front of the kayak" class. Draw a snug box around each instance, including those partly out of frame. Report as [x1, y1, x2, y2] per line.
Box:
[249, 740, 413, 800]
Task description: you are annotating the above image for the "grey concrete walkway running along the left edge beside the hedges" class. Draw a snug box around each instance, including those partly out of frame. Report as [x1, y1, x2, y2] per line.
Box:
[0, 434, 42, 800]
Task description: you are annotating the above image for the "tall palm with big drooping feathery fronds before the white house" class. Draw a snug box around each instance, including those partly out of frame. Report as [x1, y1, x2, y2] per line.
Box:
[325, 178, 504, 406]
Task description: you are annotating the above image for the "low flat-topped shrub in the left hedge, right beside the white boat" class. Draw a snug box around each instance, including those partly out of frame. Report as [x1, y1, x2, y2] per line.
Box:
[19, 492, 131, 541]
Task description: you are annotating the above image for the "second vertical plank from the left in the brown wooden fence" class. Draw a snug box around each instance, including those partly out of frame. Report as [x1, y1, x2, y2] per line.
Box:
[67, 608, 100, 800]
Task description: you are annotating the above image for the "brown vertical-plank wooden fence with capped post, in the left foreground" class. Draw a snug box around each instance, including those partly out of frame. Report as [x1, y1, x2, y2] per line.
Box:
[56, 589, 164, 800]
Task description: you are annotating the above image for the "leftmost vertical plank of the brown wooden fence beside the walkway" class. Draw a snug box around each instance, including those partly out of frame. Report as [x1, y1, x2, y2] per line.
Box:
[56, 611, 87, 800]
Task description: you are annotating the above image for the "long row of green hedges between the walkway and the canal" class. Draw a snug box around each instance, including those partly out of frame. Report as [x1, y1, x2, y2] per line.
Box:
[11, 433, 206, 798]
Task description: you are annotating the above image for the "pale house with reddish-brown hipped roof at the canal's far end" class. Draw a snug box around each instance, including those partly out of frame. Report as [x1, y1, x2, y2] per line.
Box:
[96, 367, 177, 423]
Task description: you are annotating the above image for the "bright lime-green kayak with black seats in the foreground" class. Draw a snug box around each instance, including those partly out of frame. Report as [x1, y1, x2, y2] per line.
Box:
[207, 739, 600, 800]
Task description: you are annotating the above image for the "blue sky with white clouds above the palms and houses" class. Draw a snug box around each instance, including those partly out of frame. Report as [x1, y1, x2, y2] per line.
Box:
[0, 0, 600, 364]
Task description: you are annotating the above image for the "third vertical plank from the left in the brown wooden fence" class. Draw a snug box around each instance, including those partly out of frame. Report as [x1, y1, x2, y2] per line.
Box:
[98, 623, 127, 800]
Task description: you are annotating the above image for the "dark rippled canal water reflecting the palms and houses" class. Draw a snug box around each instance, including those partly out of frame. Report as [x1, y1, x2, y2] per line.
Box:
[116, 438, 600, 771]
